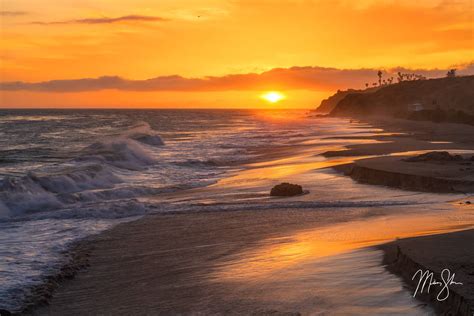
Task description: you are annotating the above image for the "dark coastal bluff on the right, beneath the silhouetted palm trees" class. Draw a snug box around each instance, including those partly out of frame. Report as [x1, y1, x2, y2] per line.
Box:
[316, 76, 474, 124]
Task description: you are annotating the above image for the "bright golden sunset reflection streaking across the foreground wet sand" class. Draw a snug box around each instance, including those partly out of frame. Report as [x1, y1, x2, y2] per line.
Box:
[214, 203, 474, 281]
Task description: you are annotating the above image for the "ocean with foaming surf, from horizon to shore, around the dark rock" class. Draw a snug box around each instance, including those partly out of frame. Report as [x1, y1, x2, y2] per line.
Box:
[0, 110, 468, 311]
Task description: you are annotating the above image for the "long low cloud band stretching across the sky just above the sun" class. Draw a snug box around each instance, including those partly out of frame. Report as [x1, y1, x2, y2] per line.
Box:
[0, 63, 474, 92]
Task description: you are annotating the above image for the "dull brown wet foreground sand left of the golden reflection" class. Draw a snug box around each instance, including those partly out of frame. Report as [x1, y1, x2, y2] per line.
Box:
[33, 210, 362, 315]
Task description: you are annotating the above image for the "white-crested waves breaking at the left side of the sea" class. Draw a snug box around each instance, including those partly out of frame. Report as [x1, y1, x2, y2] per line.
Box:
[0, 124, 164, 219]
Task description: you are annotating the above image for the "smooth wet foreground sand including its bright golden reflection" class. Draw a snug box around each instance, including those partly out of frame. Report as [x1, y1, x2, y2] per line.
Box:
[32, 205, 472, 315]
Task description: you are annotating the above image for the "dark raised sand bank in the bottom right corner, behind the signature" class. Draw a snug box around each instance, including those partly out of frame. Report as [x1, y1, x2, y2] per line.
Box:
[381, 229, 474, 316]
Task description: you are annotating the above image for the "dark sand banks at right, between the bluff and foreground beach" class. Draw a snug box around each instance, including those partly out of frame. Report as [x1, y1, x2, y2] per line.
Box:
[323, 118, 474, 194]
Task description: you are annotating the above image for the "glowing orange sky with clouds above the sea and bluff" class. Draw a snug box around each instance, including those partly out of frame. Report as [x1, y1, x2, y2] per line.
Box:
[0, 0, 474, 107]
